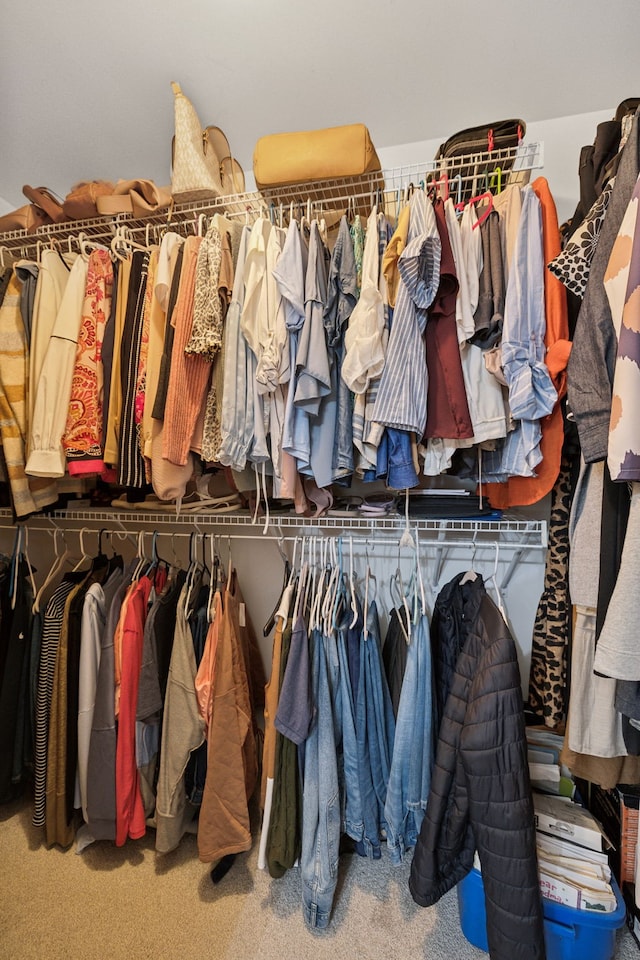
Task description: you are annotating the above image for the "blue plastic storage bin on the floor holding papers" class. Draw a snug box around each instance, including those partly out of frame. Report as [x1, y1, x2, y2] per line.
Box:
[458, 870, 626, 960]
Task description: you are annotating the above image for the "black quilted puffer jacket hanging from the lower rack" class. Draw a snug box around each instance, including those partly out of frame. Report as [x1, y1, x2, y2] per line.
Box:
[409, 574, 545, 960]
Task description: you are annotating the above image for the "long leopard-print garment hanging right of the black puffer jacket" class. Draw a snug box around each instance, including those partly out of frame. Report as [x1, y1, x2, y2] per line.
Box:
[529, 457, 572, 727]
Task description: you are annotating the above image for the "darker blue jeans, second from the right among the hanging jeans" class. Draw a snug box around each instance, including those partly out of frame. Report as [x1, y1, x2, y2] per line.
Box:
[356, 603, 395, 860]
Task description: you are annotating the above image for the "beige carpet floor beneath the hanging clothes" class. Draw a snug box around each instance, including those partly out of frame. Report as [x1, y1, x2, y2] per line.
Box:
[0, 801, 639, 960]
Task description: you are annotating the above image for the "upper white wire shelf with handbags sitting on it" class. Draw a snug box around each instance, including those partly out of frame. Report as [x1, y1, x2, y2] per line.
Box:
[0, 142, 544, 256]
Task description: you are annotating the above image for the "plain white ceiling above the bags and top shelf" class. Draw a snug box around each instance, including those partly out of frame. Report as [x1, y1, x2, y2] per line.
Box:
[0, 0, 640, 206]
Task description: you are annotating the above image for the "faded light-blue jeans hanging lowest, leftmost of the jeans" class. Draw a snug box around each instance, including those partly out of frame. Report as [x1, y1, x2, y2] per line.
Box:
[300, 630, 340, 928]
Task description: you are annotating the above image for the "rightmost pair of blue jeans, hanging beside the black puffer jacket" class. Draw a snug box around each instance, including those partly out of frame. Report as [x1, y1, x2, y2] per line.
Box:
[384, 615, 434, 863]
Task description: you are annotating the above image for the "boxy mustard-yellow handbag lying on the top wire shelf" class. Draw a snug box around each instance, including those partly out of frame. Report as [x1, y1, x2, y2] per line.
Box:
[253, 123, 380, 190]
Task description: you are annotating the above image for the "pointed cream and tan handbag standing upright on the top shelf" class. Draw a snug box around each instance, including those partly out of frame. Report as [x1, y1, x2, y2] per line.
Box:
[171, 81, 244, 203]
